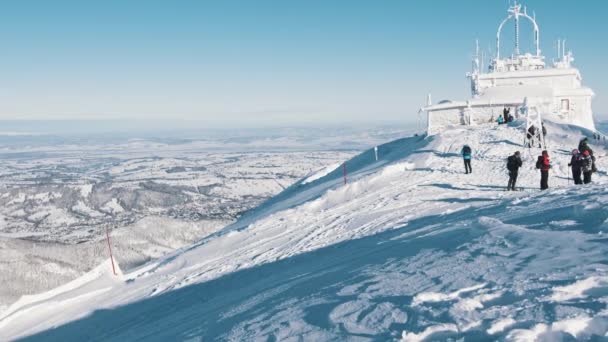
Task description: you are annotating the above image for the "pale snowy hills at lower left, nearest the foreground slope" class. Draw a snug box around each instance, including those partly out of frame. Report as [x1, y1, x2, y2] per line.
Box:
[0, 216, 230, 311]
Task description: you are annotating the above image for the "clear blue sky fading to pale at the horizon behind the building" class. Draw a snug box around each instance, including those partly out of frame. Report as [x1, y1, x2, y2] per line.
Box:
[0, 0, 608, 125]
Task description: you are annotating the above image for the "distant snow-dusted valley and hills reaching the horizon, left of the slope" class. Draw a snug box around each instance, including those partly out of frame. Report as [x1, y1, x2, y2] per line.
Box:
[0, 147, 355, 311]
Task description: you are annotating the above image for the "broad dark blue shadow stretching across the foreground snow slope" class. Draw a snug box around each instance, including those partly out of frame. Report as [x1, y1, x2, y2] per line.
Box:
[24, 187, 608, 341]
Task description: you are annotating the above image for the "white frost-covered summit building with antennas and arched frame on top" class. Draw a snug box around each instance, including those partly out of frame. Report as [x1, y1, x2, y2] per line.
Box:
[421, 3, 595, 134]
